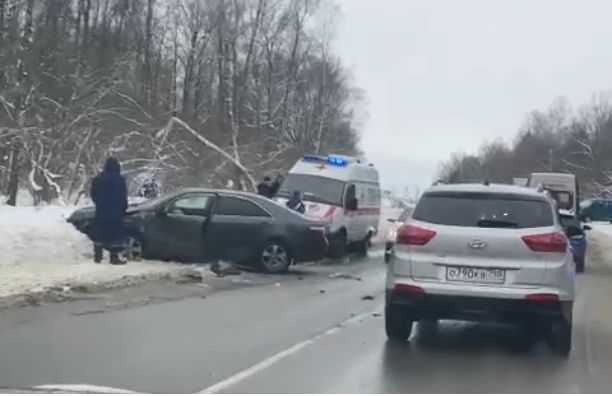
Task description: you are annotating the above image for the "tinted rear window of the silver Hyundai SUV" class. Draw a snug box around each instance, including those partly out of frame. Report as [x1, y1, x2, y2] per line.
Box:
[412, 192, 555, 228]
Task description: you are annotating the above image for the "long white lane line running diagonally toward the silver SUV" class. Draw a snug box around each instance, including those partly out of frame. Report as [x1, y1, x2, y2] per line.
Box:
[198, 307, 382, 395]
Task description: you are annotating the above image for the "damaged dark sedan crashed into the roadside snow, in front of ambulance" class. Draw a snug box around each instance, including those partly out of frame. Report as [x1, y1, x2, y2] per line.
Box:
[67, 189, 328, 273]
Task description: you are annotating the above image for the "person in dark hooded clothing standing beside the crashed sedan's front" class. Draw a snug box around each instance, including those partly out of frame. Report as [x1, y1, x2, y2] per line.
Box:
[91, 157, 128, 265]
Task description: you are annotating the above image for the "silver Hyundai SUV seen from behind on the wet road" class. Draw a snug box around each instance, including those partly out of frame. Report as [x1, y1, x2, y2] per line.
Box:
[385, 183, 574, 356]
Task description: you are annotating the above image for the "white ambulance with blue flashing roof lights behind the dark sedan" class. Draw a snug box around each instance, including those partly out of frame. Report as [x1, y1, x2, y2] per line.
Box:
[276, 155, 380, 257]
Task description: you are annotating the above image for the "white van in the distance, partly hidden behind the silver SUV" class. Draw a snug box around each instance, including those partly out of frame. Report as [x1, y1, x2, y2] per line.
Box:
[527, 173, 580, 217]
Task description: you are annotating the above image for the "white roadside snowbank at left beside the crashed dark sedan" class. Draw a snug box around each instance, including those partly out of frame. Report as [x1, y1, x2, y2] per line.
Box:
[0, 206, 207, 299]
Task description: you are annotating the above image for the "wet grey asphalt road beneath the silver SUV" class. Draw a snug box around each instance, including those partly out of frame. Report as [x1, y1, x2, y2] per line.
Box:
[0, 248, 612, 393]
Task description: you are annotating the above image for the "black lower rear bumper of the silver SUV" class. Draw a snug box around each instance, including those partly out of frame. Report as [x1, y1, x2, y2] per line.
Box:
[386, 290, 573, 323]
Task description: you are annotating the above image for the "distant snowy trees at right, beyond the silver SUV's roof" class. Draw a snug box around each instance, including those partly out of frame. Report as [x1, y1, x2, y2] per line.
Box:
[438, 93, 612, 197]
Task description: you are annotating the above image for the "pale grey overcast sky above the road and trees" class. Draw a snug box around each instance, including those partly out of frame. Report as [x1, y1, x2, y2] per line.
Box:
[336, 0, 612, 193]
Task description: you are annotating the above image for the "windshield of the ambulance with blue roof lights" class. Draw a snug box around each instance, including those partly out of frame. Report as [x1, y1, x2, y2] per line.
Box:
[277, 173, 345, 206]
